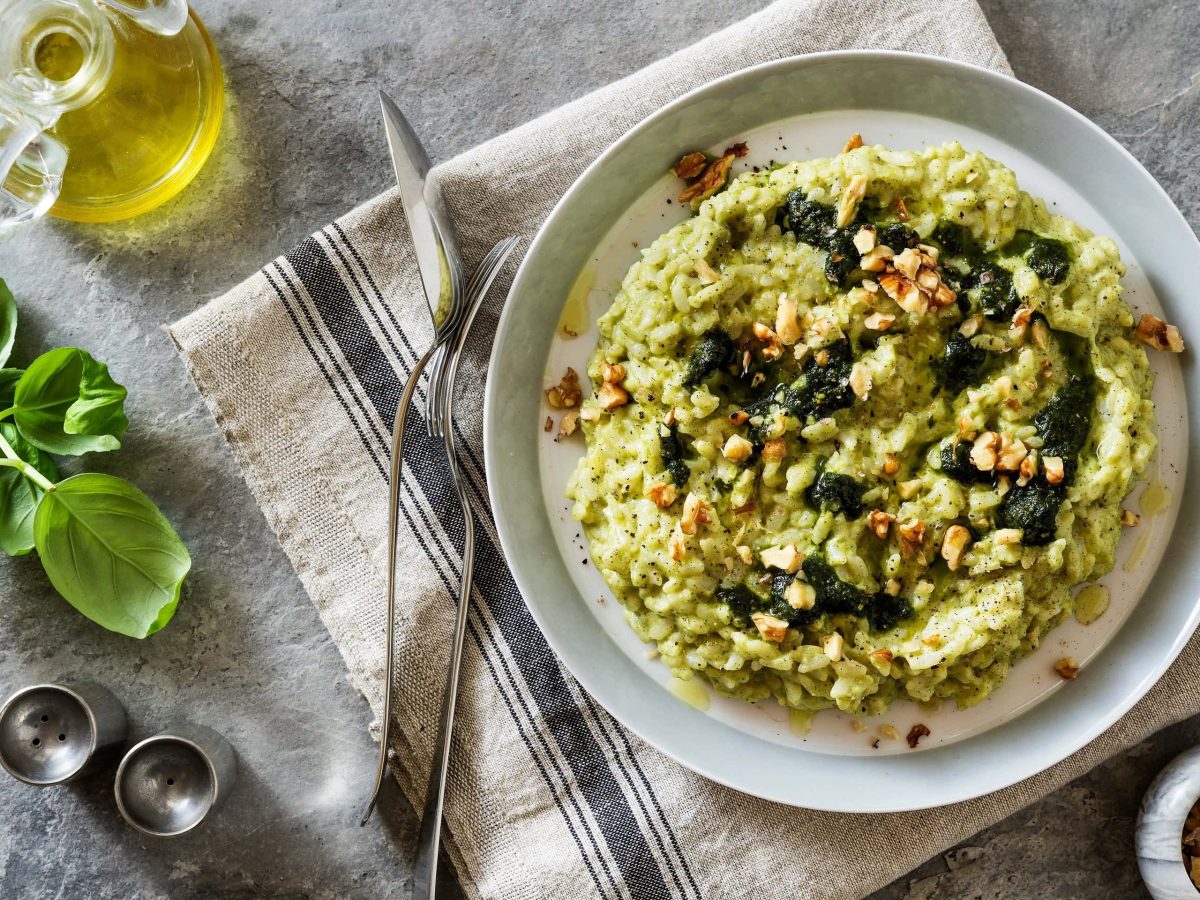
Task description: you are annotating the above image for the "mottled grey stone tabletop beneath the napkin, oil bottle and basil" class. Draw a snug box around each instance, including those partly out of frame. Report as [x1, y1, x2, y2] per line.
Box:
[0, 0, 1200, 900]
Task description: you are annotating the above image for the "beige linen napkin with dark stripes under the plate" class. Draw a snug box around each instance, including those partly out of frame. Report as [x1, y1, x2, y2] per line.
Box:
[172, 0, 1200, 900]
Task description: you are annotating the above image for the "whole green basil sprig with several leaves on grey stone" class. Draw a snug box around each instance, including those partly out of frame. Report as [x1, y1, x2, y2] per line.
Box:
[0, 280, 192, 638]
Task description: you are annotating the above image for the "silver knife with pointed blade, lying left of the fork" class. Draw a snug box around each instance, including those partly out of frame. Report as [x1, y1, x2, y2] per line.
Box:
[361, 91, 464, 824]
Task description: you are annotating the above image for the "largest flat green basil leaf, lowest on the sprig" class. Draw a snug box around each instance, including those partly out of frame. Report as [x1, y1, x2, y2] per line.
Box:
[34, 472, 192, 638]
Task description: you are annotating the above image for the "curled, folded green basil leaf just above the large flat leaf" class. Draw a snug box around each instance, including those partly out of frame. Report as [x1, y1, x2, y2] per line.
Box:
[13, 347, 130, 456]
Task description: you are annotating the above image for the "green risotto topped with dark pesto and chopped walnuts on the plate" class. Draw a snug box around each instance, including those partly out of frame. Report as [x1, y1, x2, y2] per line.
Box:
[568, 144, 1166, 714]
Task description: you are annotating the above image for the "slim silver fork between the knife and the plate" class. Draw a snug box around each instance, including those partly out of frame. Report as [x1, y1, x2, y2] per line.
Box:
[413, 238, 517, 900]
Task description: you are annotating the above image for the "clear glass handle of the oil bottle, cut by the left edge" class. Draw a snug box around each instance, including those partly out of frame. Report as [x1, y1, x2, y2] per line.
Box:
[0, 109, 67, 236]
